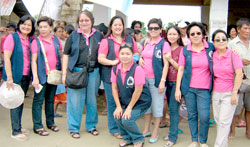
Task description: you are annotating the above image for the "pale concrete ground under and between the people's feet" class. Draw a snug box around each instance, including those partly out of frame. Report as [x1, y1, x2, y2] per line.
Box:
[0, 88, 250, 147]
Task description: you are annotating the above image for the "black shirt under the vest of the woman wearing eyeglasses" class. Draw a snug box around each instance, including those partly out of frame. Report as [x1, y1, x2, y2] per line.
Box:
[64, 34, 89, 68]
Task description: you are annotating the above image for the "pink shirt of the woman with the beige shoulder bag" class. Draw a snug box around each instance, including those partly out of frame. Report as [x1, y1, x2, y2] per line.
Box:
[31, 34, 62, 74]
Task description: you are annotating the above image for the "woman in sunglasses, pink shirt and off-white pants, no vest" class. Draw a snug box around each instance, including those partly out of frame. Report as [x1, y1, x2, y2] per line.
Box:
[212, 30, 243, 147]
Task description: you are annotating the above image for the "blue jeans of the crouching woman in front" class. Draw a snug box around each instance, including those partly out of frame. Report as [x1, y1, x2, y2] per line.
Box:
[115, 109, 145, 144]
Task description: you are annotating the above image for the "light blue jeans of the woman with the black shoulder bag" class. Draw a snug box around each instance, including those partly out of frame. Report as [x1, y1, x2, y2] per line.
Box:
[67, 68, 100, 132]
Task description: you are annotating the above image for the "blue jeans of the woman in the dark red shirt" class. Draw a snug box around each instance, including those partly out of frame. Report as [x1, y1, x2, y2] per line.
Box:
[166, 82, 180, 143]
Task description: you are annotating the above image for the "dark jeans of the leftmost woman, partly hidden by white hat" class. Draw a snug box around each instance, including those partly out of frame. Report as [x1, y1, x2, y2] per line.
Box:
[10, 76, 30, 135]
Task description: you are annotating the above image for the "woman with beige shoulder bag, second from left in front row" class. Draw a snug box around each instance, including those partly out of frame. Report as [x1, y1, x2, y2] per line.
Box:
[31, 16, 62, 136]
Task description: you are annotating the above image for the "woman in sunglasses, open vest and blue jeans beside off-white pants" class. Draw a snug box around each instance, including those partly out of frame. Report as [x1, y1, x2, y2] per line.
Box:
[175, 22, 214, 147]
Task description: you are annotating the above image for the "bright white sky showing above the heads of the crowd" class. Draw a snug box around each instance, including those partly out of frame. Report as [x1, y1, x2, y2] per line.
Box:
[23, 0, 201, 27]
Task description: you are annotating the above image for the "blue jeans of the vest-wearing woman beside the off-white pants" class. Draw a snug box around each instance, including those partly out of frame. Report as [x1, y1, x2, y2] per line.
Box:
[184, 88, 211, 144]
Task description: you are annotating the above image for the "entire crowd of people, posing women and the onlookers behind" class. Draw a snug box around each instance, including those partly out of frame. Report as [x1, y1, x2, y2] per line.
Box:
[0, 10, 250, 147]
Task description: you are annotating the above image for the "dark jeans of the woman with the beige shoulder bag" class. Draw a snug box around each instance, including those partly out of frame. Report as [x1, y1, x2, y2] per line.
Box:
[32, 83, 57, 130]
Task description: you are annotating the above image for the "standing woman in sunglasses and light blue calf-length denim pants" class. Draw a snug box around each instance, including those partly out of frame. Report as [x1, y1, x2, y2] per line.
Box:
[139, 18, 171, 143]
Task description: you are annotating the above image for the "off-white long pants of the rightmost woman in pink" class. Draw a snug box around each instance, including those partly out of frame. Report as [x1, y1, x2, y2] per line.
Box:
[212, 92, 236, 147]
